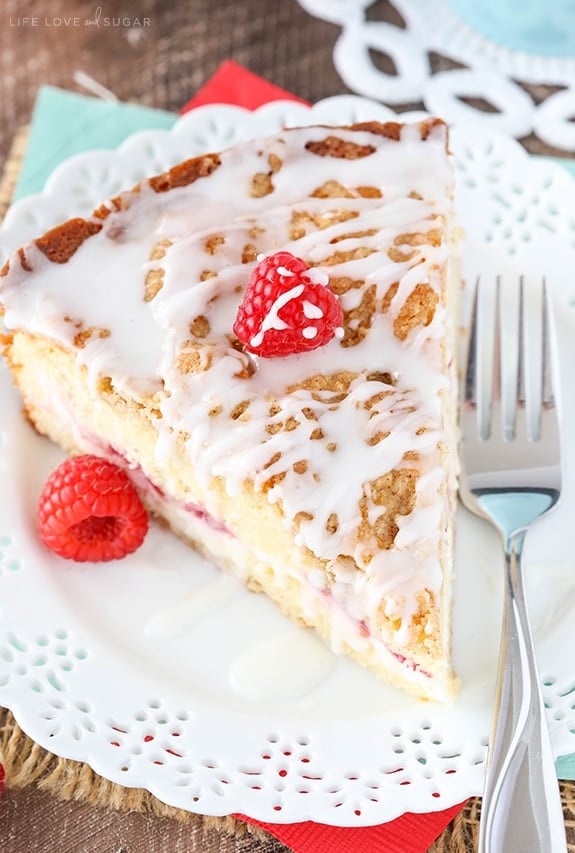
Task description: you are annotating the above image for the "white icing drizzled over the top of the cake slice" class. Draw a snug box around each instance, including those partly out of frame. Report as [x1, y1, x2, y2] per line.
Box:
[0, 121, 460, 640]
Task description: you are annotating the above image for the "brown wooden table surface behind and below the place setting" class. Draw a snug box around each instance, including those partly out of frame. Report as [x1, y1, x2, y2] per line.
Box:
[0, 0, 572, 853]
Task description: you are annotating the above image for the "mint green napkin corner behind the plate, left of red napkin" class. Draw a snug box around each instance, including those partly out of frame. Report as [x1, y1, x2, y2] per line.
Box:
[14, 86, 177, 200]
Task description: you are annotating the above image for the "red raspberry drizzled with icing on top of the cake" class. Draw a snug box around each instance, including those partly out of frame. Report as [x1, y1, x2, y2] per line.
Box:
[234, 252, 343, 358]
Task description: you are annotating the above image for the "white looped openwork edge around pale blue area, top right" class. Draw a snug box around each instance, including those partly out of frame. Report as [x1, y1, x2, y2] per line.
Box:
[298, 0, 575, 152]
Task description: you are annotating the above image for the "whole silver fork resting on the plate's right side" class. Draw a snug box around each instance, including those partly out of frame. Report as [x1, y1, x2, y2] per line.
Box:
[460, 278, 567, 853]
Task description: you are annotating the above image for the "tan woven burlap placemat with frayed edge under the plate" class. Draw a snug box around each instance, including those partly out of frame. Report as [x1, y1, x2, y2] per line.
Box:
[0, 128, 575, 853]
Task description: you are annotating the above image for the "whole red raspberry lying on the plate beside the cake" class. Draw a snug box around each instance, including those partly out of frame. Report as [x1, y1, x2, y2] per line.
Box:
[38, 455, 148, 562]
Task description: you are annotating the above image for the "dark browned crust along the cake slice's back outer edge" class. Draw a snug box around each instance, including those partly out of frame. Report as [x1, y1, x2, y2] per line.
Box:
[0, 118, 447, 282]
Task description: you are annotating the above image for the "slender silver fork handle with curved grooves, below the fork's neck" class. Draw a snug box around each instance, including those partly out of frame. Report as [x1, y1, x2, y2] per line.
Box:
[478, 529, 567, 853]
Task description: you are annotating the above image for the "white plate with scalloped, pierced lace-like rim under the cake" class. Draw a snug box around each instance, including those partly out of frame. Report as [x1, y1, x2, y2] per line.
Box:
[0, 97, 575, 826]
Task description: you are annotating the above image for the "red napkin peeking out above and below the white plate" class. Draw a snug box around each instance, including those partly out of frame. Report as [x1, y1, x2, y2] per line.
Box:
[181, 60, 470, 853]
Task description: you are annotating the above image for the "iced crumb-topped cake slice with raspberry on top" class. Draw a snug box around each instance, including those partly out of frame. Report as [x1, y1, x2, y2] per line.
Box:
[0, 120, 457, 700]
